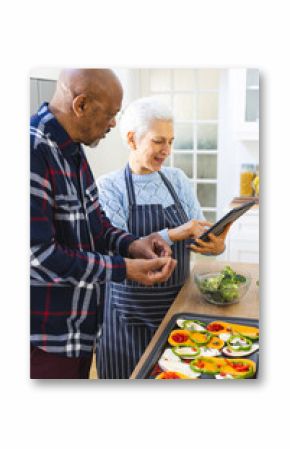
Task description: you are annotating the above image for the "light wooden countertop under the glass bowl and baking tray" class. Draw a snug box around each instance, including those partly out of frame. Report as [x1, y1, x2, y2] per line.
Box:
[131, 261, 259, 379]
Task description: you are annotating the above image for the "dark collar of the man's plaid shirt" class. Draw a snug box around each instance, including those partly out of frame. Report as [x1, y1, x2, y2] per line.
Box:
[38, 103, 80, 156]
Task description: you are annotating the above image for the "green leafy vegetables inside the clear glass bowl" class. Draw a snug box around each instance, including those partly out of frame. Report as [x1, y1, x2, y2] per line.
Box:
[198, 266, 246, 303]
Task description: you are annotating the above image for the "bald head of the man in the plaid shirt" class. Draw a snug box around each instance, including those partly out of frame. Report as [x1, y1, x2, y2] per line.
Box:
[49, 69, 123, 145]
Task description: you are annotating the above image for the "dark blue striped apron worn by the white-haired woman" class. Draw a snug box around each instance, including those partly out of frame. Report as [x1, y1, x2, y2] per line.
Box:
[97, 165, 190, 379]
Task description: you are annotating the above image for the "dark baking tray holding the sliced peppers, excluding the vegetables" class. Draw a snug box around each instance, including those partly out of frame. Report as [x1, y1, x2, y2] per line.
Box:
[136, 313, 259, 380]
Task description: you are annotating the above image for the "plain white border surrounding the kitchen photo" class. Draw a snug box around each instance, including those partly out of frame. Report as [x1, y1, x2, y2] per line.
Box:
[0, 0, 290, 449]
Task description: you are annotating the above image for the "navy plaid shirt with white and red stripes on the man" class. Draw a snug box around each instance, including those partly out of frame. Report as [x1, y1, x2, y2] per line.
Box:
[30, 103, 135, 357]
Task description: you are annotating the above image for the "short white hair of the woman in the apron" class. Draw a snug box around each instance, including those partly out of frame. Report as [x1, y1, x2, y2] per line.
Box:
[119, 97, 173, 145]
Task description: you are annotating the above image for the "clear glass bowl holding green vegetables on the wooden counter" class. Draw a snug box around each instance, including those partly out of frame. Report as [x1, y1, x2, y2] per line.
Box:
[194, 272, 251, 306]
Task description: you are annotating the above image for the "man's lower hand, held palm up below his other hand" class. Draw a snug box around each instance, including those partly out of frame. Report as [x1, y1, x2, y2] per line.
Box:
[125, 257, 176, 285]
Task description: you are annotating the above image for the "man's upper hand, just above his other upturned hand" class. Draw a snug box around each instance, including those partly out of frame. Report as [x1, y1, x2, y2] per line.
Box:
[129, 232, 172, 259]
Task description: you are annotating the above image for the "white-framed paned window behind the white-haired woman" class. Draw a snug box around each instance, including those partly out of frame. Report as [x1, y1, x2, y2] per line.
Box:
[140, 69, 220, 222]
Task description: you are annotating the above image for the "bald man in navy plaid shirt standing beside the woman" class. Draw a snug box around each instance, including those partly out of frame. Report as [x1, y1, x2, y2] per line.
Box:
[30, 69, 176, 379]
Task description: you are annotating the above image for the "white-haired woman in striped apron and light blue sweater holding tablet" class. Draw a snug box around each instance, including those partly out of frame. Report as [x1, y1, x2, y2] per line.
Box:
[97, 98, 228, 379]
